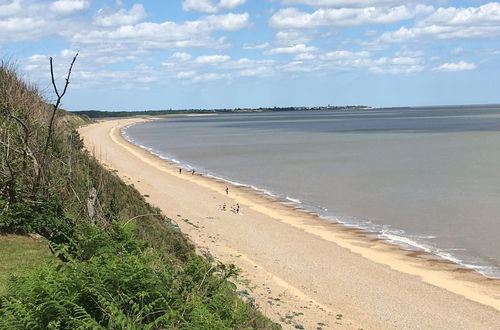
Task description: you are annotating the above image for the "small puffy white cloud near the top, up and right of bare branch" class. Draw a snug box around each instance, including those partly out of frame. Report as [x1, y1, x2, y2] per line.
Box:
[94, 4, 147, 27]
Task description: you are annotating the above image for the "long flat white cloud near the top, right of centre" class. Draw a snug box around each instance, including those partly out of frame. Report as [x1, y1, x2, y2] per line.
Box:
[270, 4, 434, 29]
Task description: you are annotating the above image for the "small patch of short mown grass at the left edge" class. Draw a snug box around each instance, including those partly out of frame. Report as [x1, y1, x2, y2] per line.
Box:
[0, 235, 54, 296]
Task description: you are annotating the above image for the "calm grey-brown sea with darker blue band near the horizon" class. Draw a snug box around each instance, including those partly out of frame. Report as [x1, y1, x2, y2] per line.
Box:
[124, 106, 500, 278]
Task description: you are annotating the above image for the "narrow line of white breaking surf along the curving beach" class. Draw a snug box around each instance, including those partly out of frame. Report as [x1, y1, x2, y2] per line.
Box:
[120, 121, 500, 280]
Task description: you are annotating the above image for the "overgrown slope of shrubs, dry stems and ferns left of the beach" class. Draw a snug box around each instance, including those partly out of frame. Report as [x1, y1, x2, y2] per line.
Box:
[0, 63, 279, 329]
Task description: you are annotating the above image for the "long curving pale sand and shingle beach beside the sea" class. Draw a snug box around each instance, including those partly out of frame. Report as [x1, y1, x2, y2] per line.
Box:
[80, 118, 500, 329]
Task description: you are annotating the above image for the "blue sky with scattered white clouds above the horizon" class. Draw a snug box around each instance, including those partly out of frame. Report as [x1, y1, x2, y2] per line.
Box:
[0, 0, 500, 110]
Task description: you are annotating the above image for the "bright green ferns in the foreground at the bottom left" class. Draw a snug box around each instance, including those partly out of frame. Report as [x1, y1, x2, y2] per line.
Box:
[0, 223, 278, 329]
